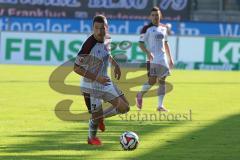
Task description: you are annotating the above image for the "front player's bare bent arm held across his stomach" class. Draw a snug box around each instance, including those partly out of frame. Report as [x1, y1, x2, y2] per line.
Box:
[74, 64, 110, 84]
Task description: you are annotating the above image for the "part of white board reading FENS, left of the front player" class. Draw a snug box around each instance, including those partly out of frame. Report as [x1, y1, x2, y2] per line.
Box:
[0, 32, 87, 65]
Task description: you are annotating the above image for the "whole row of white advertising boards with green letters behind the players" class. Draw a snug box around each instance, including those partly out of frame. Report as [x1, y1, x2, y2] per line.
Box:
[0, 31, 240, 70]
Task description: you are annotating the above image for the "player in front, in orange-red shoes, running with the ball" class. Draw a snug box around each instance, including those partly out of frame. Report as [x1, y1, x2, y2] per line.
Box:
[74, 15, 129, 145]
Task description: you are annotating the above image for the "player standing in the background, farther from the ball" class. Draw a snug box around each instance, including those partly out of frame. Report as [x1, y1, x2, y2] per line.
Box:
[136, 7, 174, 111]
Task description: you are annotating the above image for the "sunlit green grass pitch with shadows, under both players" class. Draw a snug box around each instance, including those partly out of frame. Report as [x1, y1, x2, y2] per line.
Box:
[0, 65, 240, 160]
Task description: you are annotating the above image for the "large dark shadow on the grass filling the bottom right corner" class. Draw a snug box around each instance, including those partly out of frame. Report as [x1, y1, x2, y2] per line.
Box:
[135, 114, 240, 160]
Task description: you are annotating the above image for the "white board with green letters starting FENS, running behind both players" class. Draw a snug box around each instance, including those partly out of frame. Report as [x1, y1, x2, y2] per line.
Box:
[0, 32, 176, 65]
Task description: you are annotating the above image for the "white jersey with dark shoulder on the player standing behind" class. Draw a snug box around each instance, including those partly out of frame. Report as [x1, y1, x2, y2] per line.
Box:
[139, 23, 168, 63]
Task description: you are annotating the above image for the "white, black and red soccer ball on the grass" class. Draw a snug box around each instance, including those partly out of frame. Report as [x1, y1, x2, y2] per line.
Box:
[120, 131, 139, 151]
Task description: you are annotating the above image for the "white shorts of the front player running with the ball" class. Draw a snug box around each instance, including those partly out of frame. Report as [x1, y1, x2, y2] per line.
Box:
[80, 82, 123, 113]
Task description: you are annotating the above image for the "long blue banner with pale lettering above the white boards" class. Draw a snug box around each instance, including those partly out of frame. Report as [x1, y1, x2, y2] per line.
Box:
[0, 17, 240, 37]
